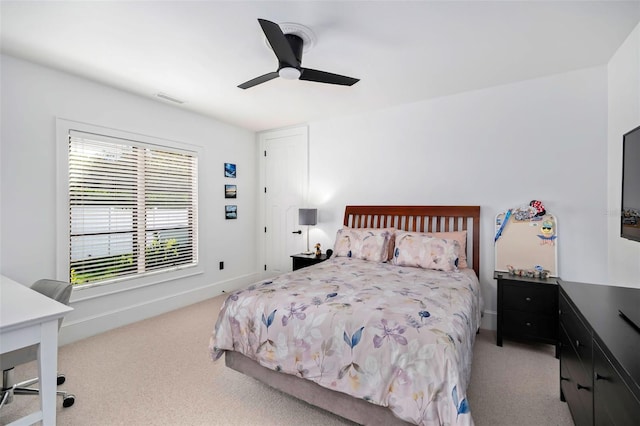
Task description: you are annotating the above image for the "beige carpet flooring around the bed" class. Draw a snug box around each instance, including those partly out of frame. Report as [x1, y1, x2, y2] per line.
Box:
[0, 296, 573, 426]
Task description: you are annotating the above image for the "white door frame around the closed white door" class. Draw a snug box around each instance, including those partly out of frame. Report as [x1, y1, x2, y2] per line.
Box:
[257, 124, 310, 278]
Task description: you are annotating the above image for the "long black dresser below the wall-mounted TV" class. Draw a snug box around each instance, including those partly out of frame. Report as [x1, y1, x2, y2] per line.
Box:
[559, 280, 640, 426]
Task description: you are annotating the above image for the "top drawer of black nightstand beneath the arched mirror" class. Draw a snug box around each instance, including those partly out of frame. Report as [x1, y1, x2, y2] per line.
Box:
[502, 284, 558, 316]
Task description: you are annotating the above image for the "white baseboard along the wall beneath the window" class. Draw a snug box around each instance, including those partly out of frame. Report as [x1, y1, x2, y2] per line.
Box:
[59, 273, 260, 346]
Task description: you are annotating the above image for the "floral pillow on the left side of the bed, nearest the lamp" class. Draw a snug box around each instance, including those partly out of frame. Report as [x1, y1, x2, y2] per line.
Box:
[333, 227, 395, 262]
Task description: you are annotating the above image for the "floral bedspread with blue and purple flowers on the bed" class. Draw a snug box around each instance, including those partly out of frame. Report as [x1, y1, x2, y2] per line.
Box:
[209, 257, 481, 425]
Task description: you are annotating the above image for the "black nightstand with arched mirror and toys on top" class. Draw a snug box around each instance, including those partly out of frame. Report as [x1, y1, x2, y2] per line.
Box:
[493, 271, 558, 357]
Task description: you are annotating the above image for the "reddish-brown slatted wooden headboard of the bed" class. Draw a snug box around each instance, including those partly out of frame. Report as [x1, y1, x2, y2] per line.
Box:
[344, 206, 480, 277]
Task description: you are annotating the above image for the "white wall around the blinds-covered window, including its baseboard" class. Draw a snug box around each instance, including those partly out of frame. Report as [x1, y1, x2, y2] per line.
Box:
[0, 56, 258, 343]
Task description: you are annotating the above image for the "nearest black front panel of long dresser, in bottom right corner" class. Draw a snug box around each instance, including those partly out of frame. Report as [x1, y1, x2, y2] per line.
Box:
[593, 343, 640, 426]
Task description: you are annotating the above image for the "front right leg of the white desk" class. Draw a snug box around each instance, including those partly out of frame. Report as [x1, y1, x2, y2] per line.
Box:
[38, 319, 58, 426]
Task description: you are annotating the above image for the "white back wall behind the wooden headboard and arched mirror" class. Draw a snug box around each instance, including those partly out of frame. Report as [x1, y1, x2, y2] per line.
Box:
[309, 66, 607, 327]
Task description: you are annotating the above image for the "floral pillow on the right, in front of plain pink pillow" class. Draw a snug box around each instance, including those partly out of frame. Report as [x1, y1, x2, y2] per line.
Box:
[392, 232, 460, 271]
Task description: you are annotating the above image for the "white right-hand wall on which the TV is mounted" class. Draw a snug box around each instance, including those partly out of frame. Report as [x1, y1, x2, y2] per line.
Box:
[607, 20, 640, 288]
